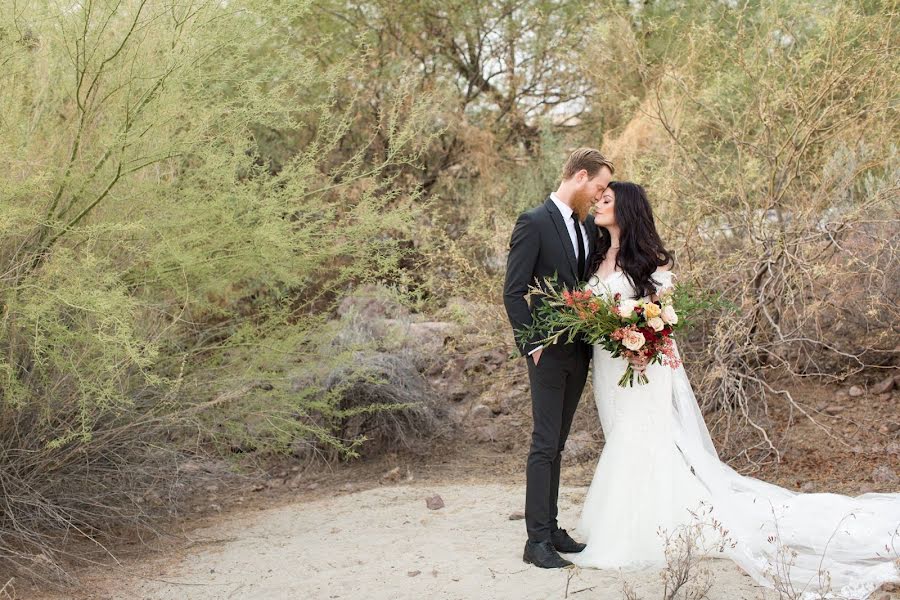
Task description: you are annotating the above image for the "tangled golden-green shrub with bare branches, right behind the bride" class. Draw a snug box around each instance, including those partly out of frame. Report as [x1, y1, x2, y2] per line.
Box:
[580, 2, 900, 459]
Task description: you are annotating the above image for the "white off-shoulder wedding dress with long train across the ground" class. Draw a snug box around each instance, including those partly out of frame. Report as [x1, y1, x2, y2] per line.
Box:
[568, 271, 900, 599]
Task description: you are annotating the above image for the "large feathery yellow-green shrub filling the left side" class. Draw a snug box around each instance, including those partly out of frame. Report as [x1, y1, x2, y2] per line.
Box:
[0, 0, 439, 580]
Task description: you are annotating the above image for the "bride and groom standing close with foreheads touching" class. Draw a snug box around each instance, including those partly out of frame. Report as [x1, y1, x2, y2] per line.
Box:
[504, 148, 900, 599]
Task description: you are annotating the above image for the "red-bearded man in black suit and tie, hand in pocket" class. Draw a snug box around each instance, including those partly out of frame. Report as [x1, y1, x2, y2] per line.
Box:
[503, 148, 613, 569]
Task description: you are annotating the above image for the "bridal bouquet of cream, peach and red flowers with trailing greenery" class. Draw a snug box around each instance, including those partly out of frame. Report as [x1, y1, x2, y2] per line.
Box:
[519, 281, 694, 387]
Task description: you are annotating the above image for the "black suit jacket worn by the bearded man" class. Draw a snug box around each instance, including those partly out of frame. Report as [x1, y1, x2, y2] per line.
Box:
[503, 197, 597, 355]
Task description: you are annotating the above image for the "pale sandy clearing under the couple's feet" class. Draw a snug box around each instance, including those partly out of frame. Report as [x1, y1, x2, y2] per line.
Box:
[67, 484, 775, 600]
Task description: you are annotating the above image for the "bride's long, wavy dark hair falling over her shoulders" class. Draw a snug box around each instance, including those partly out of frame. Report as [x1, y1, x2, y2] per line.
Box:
[590, 181, 675, 299]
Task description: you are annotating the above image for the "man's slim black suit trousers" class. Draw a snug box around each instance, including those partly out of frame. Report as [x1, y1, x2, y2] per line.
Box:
[525, 341, 591, 542]
